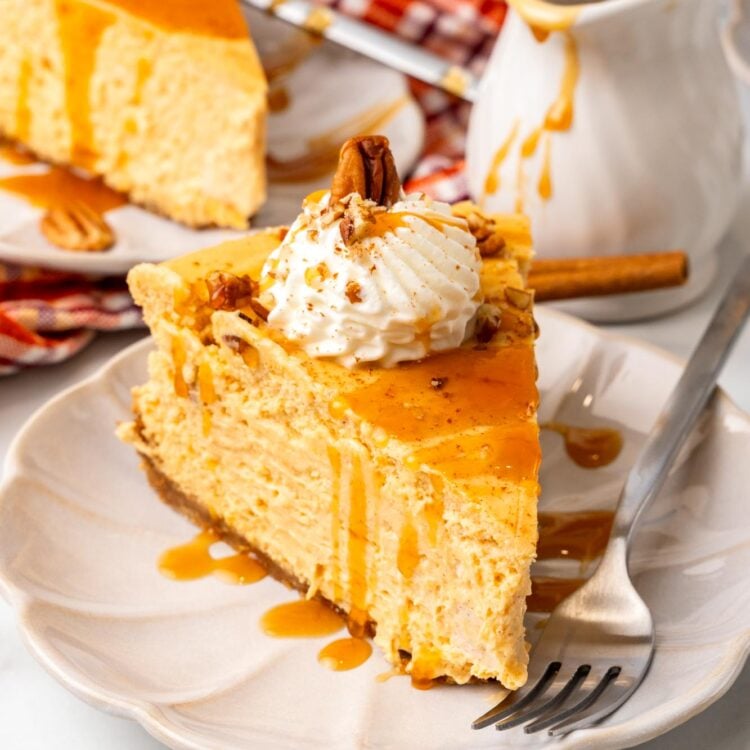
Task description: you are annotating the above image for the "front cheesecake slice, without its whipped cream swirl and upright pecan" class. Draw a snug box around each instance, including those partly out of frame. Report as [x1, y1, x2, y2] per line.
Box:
[120, 138, 540, 688]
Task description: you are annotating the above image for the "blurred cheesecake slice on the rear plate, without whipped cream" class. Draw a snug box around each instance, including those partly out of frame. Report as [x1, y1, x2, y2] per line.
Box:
[0, 0, 266, 228]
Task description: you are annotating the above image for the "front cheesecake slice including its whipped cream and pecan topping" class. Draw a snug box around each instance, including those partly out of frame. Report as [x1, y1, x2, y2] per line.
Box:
[120, 138, 540, 688]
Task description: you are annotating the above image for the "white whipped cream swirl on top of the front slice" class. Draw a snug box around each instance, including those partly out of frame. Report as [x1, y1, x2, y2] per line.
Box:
[261, 193, 482, 367]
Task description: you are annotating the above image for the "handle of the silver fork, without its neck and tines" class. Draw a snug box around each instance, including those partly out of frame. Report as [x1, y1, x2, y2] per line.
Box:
[610, 256, 750, 547]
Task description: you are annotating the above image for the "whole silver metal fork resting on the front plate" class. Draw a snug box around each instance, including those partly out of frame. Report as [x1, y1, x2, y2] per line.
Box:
[472, 257, 750, 736]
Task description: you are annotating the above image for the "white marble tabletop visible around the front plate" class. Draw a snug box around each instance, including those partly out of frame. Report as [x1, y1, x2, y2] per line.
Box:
[0, 117, 750, 750]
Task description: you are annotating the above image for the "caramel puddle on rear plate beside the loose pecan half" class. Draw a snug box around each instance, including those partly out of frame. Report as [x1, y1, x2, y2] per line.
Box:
[0, 167, 127, 214]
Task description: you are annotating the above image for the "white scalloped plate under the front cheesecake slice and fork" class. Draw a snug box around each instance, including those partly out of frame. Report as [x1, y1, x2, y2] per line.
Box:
[0, 309, 750, 750]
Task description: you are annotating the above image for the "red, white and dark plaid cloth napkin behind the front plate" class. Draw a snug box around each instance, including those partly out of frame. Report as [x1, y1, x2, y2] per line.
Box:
[0, 0, 506, 375]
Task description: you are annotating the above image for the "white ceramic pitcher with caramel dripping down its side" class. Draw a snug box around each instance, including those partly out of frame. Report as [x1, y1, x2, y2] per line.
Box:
[467, 0, 742, 320]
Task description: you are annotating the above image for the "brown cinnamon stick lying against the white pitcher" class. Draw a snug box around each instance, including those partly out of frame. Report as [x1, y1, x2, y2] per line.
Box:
[528, 251, 688, 301]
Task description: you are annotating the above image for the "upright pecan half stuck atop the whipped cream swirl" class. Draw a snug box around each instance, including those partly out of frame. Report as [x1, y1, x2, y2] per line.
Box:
[330, 135, 401, 207]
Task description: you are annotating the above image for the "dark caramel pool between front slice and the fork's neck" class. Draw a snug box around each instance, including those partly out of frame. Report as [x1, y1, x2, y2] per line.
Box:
[537, 510, 614, 562]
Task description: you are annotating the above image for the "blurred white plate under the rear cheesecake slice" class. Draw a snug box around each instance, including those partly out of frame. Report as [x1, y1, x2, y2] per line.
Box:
[0, 9, 424, 274]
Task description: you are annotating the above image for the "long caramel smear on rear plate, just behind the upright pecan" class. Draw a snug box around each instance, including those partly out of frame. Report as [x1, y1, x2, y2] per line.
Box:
[266, 96, 409, 183]
